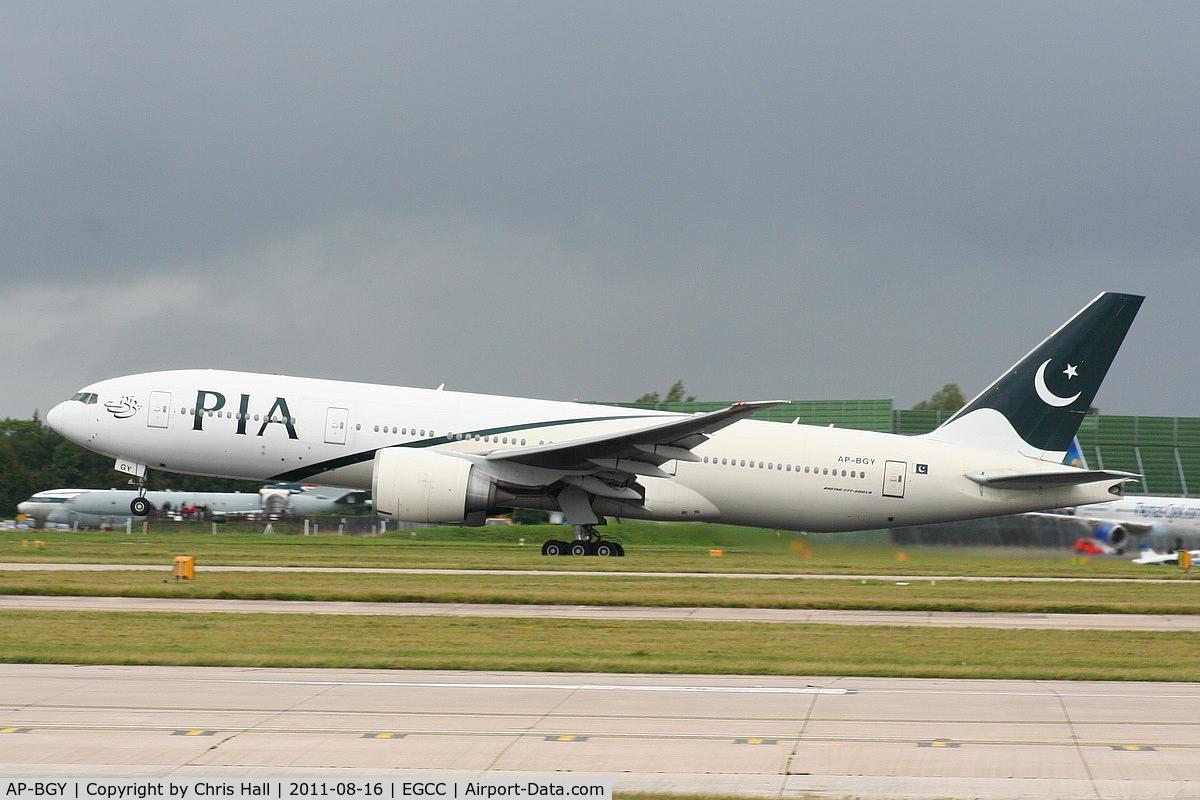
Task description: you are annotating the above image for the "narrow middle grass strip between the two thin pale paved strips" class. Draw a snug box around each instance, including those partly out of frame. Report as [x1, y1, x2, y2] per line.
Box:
[0, 567, 1200, 614]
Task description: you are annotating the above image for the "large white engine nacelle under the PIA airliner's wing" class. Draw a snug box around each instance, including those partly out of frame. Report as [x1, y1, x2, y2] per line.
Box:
[371, 447, 496, 525]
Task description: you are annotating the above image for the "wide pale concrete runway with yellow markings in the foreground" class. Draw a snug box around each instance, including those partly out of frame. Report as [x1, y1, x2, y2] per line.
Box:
[0, 664, 1200, 800]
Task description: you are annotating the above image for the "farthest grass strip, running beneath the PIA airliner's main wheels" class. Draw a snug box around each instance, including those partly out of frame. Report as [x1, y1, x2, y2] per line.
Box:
[0, 522, 1186, 579]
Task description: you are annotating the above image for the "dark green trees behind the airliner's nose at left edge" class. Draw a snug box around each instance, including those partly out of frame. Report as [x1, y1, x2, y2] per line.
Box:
[0, 415, 259, 519]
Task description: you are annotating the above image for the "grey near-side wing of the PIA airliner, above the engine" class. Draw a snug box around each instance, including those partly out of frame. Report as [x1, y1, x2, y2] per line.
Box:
[486, 401, 787, 477]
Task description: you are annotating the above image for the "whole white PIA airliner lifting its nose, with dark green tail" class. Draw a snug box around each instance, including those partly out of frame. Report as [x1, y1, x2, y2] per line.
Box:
[47, 293, 1142, 555]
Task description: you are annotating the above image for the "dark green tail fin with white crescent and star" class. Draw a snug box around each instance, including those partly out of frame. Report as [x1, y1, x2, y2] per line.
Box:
[926, 293, 1145, 462]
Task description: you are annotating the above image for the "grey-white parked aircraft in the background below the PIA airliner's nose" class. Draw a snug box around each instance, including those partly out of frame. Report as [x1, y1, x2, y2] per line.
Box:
[18, 483, 371, 528]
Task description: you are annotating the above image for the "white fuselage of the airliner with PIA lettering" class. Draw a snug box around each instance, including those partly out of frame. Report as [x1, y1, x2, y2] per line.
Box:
[48, 369, 1121, 531]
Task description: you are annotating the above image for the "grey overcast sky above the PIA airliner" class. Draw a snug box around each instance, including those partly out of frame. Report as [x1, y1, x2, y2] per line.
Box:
[0, 0, 1200, 419]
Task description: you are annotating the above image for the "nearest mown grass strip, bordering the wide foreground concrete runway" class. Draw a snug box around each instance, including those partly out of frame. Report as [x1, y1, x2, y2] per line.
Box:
[0, 612, 1200, 681]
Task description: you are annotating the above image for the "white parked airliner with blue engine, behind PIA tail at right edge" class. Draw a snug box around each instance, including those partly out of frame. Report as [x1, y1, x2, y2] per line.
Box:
[1034, 440, 1200, 553]
